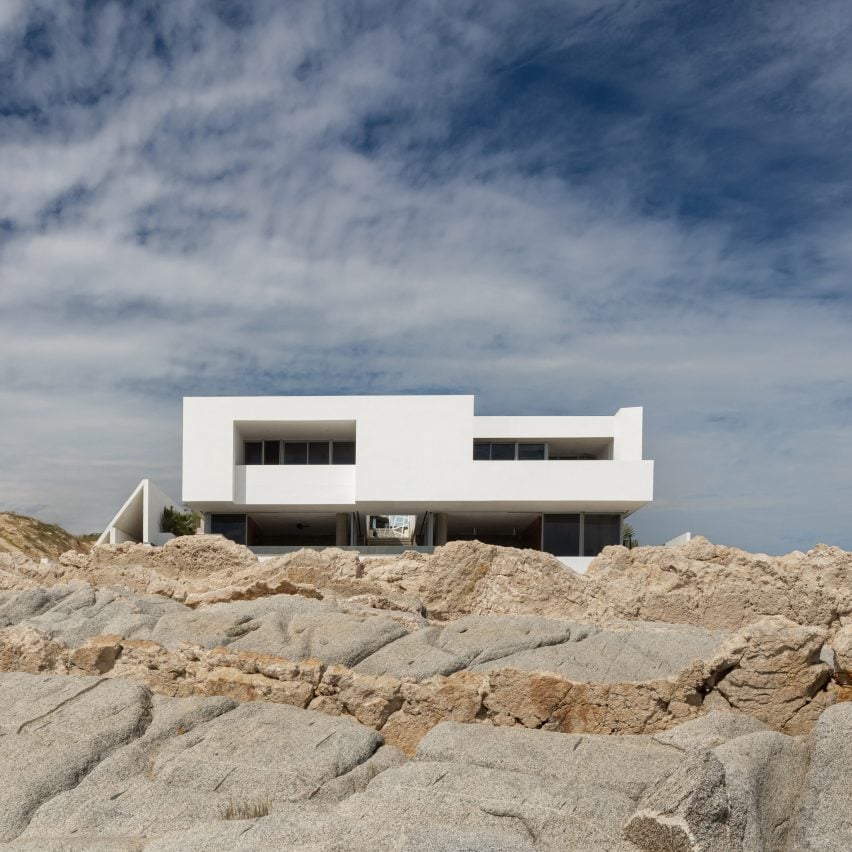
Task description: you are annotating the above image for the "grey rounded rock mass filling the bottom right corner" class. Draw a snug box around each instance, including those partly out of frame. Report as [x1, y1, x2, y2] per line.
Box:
[625, 704, 852, 852]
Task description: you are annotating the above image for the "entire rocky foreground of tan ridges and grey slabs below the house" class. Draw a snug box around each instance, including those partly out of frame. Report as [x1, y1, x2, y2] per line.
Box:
[0, 536, 852, 852]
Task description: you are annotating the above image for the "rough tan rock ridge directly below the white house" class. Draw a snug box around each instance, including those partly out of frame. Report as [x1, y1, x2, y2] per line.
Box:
[6, 536, 852, 632]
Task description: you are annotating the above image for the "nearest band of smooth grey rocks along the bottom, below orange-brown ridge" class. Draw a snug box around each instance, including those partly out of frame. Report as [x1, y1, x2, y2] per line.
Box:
[6, 673, 852, 852]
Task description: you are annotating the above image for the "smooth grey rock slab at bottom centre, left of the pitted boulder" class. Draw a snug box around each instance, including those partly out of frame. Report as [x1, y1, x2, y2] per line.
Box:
[337, 723, 680, 852]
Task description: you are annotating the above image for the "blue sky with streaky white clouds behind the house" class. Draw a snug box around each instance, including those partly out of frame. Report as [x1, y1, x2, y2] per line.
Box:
[0, 0, 852, 553]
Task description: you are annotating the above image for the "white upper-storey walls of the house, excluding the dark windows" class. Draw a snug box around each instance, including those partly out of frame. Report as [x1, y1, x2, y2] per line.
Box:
[183, 396, 653, 513]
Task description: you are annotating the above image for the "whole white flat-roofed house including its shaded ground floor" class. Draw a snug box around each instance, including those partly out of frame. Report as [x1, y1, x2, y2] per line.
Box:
[183, 396, 653, 569]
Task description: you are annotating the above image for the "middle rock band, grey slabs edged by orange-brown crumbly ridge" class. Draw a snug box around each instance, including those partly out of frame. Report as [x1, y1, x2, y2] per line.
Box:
[0, 583, 837, 753]
